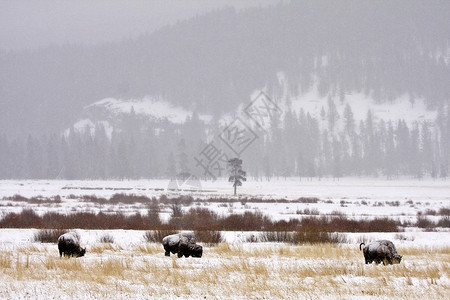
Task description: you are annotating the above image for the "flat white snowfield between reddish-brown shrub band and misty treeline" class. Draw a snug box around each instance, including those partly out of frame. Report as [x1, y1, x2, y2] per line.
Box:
[0, 178, 450, 222]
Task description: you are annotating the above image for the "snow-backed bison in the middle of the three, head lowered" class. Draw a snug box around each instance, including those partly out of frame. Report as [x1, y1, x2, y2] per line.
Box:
[162, 233, 203, 257]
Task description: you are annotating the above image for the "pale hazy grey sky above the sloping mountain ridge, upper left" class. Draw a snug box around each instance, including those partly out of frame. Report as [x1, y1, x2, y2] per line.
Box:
[0, 0, 279, 50]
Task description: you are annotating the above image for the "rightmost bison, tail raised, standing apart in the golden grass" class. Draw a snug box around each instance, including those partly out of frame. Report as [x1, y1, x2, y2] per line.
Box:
[359, 240, 402, 265]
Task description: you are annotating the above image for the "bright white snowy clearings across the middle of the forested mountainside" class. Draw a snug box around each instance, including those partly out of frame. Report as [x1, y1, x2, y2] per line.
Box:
[73, 85, 436, 136]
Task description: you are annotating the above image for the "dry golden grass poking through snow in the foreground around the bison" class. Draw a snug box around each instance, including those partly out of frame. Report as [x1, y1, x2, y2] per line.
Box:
[0, 244, 450, 299]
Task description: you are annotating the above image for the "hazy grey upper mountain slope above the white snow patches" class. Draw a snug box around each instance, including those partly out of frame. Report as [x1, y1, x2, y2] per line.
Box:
[0, 0, 450, 135]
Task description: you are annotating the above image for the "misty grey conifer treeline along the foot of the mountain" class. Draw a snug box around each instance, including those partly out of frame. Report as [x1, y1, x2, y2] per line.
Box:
[0, 98, 450, 180]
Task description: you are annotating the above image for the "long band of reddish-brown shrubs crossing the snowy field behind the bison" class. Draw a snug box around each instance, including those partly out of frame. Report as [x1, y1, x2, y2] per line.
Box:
[0, 207, 400, 232]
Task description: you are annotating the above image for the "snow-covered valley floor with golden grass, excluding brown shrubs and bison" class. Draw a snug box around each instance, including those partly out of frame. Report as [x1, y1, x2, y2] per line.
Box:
[0, 178, 450, 299]
